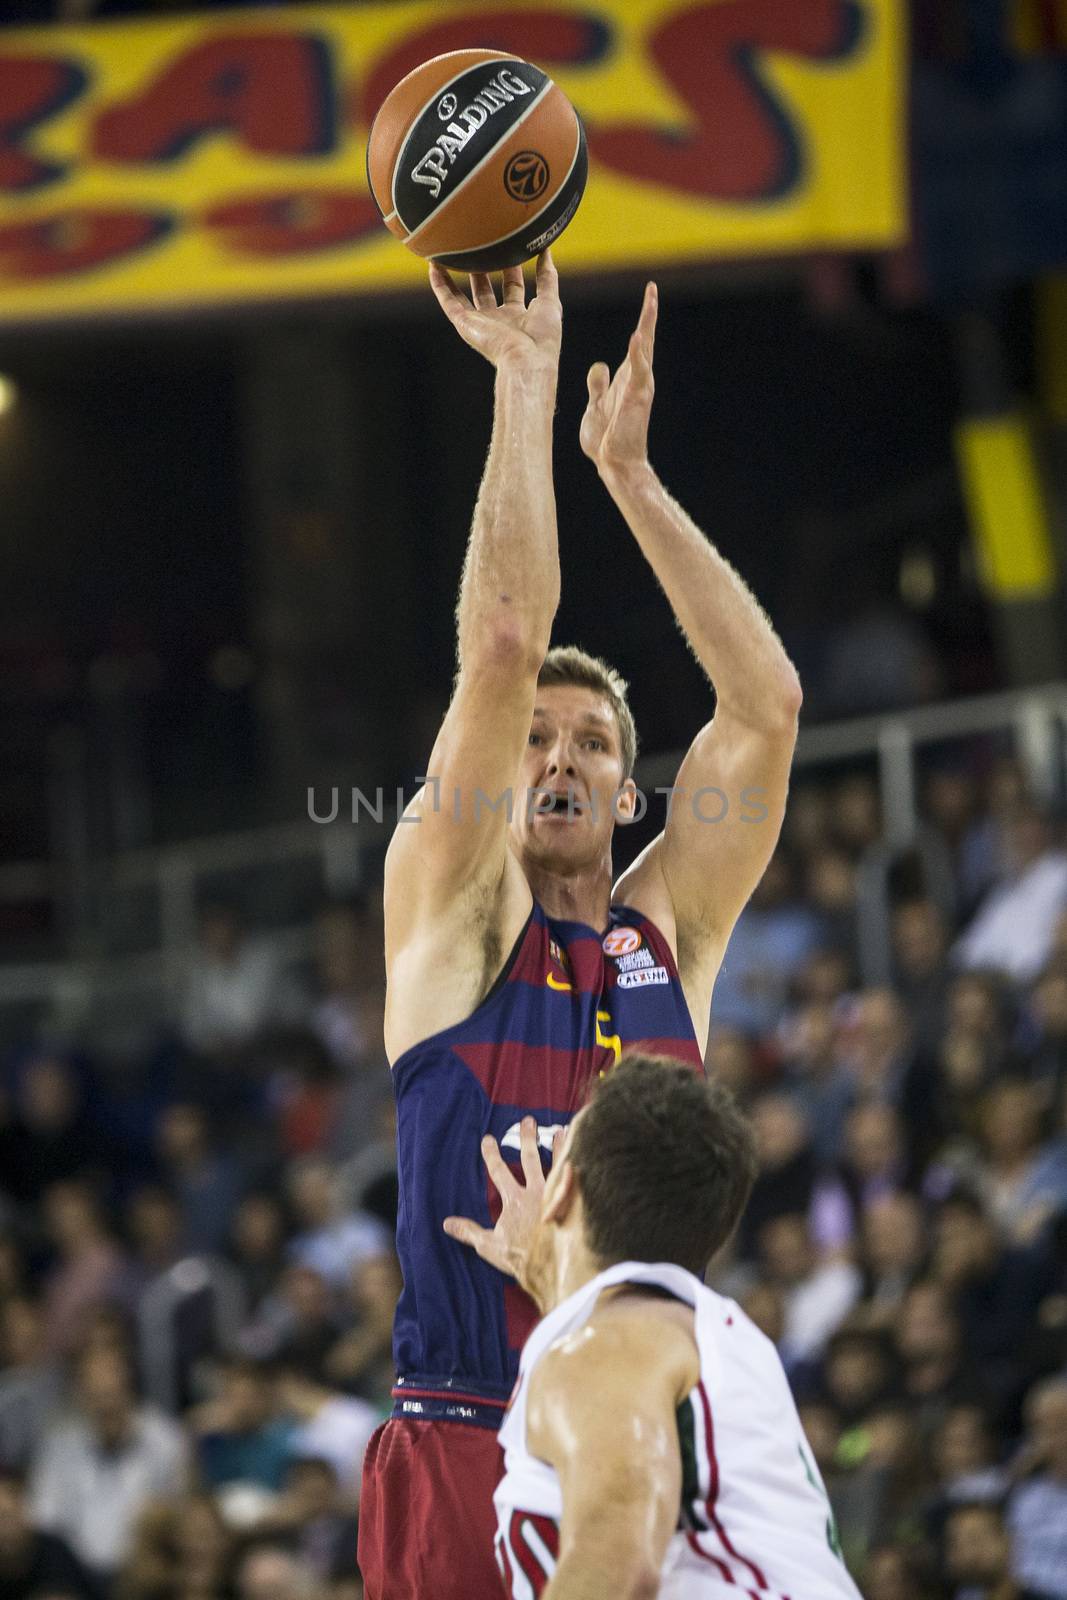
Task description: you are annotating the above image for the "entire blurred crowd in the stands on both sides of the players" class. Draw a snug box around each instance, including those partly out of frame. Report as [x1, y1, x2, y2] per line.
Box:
[0, 758, 1067, 1600]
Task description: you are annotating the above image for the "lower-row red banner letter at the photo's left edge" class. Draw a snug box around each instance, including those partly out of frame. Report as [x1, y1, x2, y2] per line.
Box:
[0, 210, 171, 283]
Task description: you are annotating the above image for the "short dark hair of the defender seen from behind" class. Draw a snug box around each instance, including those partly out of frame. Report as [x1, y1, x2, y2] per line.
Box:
[568, 1051, 757, 1275]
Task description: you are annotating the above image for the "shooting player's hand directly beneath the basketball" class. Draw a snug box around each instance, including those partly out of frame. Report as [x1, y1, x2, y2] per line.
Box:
[430, 250, 563, 370]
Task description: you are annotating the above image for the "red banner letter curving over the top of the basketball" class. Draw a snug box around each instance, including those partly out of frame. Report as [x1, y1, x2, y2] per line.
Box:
[363, 6, 611, 123]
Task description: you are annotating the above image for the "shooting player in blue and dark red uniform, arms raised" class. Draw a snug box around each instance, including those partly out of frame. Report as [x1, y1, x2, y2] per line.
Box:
[360, 253, 800, 1600]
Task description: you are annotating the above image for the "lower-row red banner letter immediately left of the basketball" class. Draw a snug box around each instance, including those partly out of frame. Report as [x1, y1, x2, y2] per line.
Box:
[202, 189, 381, 256]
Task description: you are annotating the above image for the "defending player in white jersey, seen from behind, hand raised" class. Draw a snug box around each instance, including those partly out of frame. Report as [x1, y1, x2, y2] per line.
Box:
[453, 1054, 859, 1600]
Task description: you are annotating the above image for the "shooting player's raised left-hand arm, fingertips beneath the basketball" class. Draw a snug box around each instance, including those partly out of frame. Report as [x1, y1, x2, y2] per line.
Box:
[386, 253, 561, 1053]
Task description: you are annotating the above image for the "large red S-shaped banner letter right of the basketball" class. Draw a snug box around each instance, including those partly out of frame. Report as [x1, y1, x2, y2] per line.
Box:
[589, 0, 864, 200]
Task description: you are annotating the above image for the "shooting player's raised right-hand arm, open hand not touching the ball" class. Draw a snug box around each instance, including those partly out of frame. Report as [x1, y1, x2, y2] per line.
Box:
[581, 283, 801, 998]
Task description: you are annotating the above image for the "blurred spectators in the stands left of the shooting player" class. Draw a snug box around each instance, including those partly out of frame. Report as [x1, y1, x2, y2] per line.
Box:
[0, 902, 400, 1600]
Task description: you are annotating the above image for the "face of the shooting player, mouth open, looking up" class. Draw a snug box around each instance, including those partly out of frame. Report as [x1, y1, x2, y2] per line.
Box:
[512, 685, 635, 870]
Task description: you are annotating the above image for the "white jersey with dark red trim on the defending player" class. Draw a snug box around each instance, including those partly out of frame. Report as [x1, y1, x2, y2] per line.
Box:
[494, 1261, 859, 1600]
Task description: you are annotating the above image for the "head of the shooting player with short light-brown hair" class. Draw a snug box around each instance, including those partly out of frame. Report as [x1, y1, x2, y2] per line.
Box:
[512, 646, 637, 872]
